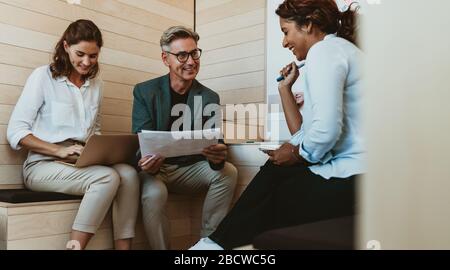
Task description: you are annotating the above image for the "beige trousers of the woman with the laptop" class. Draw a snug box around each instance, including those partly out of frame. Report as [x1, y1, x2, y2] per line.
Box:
[23, 160, 140, 240]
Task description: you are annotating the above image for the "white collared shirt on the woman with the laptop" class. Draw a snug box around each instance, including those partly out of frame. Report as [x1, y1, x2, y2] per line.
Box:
[7, 65, 103, 150]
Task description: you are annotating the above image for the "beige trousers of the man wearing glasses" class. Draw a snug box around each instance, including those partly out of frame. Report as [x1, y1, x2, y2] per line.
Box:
[139, 161, 237, 249]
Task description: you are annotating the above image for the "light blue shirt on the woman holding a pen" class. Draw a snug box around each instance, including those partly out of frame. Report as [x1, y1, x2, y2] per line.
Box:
[290, 35, 366, 179]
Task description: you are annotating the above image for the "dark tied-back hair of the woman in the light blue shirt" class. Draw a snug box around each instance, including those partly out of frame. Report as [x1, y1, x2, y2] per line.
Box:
[275, 0, 359, 45]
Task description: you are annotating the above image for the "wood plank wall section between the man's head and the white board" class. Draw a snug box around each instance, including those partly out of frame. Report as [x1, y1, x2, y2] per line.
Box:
[196, 0, 266, 141]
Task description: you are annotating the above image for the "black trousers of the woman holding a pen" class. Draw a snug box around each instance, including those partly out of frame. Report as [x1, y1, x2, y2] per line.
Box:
[209, 161, 356, 249]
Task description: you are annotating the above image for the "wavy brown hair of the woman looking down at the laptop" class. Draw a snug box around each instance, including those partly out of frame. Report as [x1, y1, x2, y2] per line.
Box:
[50, 20, 103, 79]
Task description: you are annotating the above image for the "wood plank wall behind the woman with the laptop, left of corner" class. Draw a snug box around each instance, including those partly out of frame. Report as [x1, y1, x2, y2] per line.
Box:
[0, 0, 193, 189]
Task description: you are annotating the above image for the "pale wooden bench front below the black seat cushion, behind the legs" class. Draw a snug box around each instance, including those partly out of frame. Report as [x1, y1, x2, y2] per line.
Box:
[0, 194, 193, 249]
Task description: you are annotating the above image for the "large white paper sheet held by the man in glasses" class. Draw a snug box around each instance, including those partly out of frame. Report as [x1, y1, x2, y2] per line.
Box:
[138, 129, 221, 157]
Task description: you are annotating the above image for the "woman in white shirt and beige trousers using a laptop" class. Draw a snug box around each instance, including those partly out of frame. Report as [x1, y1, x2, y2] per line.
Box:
[7, 20, 139, 249]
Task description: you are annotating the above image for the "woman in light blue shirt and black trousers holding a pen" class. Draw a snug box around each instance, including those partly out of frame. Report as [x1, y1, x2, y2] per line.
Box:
[192, 0, 365, 249]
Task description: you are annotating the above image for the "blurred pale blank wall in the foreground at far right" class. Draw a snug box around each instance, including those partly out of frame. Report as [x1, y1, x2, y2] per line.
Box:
[359, 0, 450, 249]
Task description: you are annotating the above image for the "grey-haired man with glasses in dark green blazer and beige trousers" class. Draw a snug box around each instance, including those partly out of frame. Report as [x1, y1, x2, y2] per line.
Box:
[132, 26, 237, 249]
